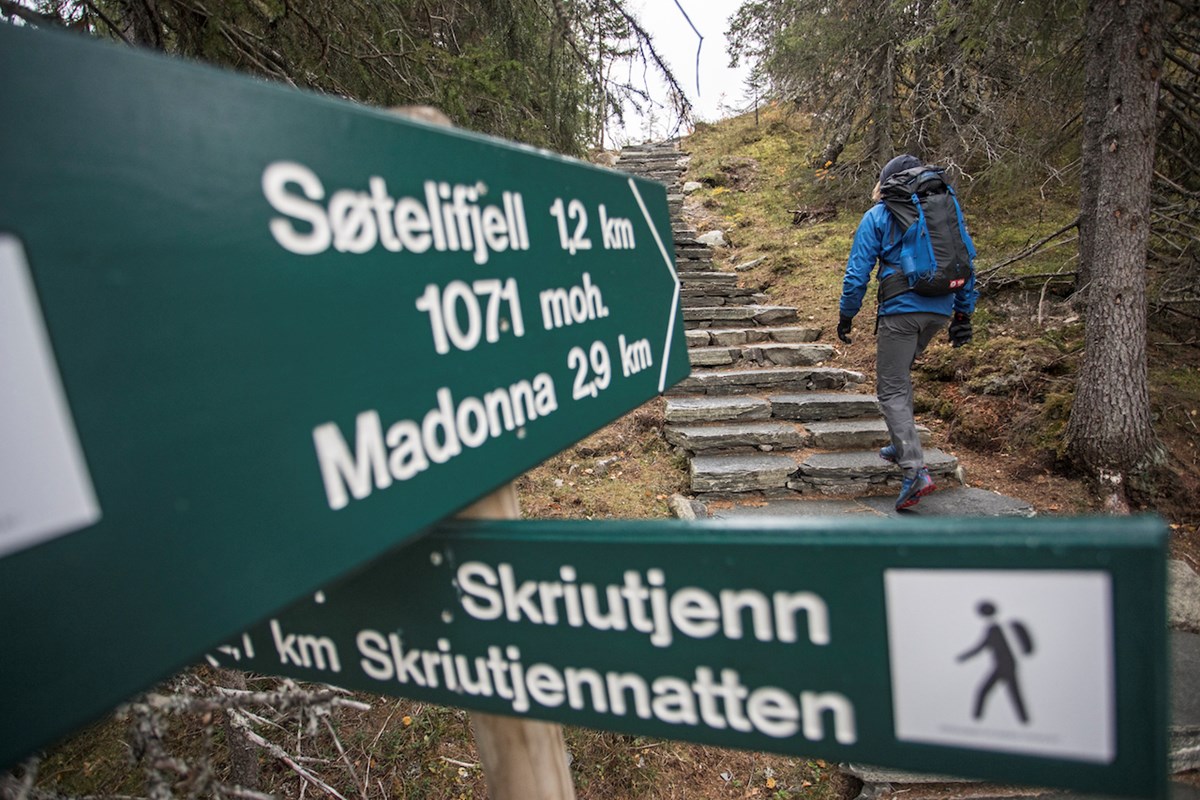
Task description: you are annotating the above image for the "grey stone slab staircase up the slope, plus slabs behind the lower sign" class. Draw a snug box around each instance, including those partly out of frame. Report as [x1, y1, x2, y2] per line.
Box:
[617, 143, 1200, 800]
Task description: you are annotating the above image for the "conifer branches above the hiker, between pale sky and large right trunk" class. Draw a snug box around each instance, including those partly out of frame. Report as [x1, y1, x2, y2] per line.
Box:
[730, 0, 1082, 173]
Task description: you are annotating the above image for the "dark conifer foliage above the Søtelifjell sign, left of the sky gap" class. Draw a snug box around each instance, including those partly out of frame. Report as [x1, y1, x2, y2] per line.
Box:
[0, 0, 690, 155]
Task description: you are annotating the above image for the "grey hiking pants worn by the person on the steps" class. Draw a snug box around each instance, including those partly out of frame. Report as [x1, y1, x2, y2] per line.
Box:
[875, 312, 950, 477]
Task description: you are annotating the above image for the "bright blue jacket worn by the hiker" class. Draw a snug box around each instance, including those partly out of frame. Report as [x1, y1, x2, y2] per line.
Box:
[838, 203, 979, 317]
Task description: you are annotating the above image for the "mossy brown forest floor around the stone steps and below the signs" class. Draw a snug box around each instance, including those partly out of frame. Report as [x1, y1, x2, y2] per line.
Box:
[21, 110, 1200, 800]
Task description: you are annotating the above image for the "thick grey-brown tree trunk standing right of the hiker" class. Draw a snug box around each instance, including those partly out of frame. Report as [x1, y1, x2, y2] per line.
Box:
[1067, 0, 1164, 509]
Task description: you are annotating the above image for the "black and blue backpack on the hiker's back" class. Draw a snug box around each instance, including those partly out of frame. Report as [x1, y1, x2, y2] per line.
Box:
[880, 167, 976, 302]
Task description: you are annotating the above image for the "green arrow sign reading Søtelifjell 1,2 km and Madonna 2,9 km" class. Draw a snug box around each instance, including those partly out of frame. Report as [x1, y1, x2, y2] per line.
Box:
[0, 25, 689, 764]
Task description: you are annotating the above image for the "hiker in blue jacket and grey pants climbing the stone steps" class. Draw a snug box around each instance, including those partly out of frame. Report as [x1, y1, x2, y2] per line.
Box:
[838, 155, 977, 511]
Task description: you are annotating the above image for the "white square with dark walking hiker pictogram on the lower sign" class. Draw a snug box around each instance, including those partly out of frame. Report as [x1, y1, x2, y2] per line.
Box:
[884, 570, 1116, 763]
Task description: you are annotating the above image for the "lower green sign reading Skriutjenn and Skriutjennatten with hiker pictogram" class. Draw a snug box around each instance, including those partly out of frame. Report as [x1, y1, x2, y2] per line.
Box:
[210, 517, 1168, 798]
